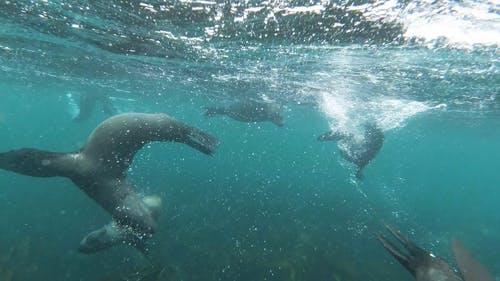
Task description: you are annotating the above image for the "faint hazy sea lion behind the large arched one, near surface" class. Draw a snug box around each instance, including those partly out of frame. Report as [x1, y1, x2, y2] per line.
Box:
[73, 92, 117, 122]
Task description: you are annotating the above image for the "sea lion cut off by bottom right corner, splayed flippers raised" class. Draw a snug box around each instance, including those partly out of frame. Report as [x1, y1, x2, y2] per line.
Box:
[377, 225, 494, 281]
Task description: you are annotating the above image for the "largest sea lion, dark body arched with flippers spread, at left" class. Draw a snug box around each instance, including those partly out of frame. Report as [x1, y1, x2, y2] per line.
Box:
[0, 113, 218, 253]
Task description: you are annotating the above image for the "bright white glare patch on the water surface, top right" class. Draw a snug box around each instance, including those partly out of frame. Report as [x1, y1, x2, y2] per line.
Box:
[351, 0, 500, 49]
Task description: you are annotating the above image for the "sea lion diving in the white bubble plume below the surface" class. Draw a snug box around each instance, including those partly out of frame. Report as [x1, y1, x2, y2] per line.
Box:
[318, 123, 384, 179]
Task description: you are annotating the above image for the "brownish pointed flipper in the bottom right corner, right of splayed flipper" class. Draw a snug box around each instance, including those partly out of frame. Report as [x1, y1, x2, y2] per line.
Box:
[452, 240, 495, 281]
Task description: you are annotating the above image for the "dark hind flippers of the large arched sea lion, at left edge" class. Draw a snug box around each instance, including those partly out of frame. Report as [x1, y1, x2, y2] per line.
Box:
[0, 148, 72, 177]
